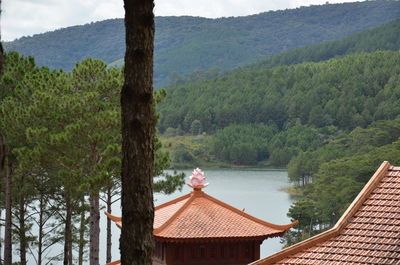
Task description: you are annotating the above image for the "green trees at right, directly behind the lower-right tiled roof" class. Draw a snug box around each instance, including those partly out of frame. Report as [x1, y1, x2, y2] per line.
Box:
[285, 117, 400, 244]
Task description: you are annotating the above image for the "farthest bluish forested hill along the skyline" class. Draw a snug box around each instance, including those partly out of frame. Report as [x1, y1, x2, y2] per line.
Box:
[5, 0, 400, 87]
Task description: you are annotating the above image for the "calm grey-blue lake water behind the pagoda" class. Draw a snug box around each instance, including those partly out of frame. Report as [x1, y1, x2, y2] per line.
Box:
[100, 168, 294, 264]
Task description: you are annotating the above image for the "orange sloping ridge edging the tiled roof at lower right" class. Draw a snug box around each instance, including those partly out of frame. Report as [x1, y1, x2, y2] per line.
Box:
[250, 161, 391, 265]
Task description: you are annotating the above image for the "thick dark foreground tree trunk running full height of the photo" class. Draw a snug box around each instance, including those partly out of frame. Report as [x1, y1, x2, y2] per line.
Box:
[120, 0, 155, 265]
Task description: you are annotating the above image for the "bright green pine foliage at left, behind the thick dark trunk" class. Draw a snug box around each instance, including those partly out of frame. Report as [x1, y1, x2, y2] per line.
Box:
[1, 54, 184, 195]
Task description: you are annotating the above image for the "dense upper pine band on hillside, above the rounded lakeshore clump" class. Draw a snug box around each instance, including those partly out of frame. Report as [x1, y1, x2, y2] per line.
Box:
[158, 51, 400, 134]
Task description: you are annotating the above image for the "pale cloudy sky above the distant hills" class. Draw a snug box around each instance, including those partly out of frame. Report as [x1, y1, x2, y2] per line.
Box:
[0, 0, 355, 41]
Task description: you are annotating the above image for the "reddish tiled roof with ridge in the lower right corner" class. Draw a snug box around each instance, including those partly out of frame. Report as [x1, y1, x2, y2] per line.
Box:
[251, 162, 400, 265]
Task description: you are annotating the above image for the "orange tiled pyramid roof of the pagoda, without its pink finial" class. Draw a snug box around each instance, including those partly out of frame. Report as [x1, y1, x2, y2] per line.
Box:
[106, 190, 297, 241]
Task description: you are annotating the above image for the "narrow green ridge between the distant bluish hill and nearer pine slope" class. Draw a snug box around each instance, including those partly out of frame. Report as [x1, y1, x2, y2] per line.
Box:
[168, 19, 400, 87]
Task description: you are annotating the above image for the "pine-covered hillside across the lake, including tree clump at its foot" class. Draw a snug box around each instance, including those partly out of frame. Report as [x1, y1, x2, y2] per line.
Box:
[158, 51, 400, 167]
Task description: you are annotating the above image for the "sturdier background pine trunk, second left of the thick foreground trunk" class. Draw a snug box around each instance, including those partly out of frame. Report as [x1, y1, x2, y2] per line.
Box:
[89, 193, 100, 265]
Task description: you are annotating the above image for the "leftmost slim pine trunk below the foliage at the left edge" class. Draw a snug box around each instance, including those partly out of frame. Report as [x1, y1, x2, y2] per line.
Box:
[4, 155, 13, 265]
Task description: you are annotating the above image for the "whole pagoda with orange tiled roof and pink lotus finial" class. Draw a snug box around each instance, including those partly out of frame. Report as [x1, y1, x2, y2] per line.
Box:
[106, 168, 297, 265]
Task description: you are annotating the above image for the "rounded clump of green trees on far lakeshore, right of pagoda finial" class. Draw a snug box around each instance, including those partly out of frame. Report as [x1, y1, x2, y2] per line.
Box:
[212, 124, 276, 165]
